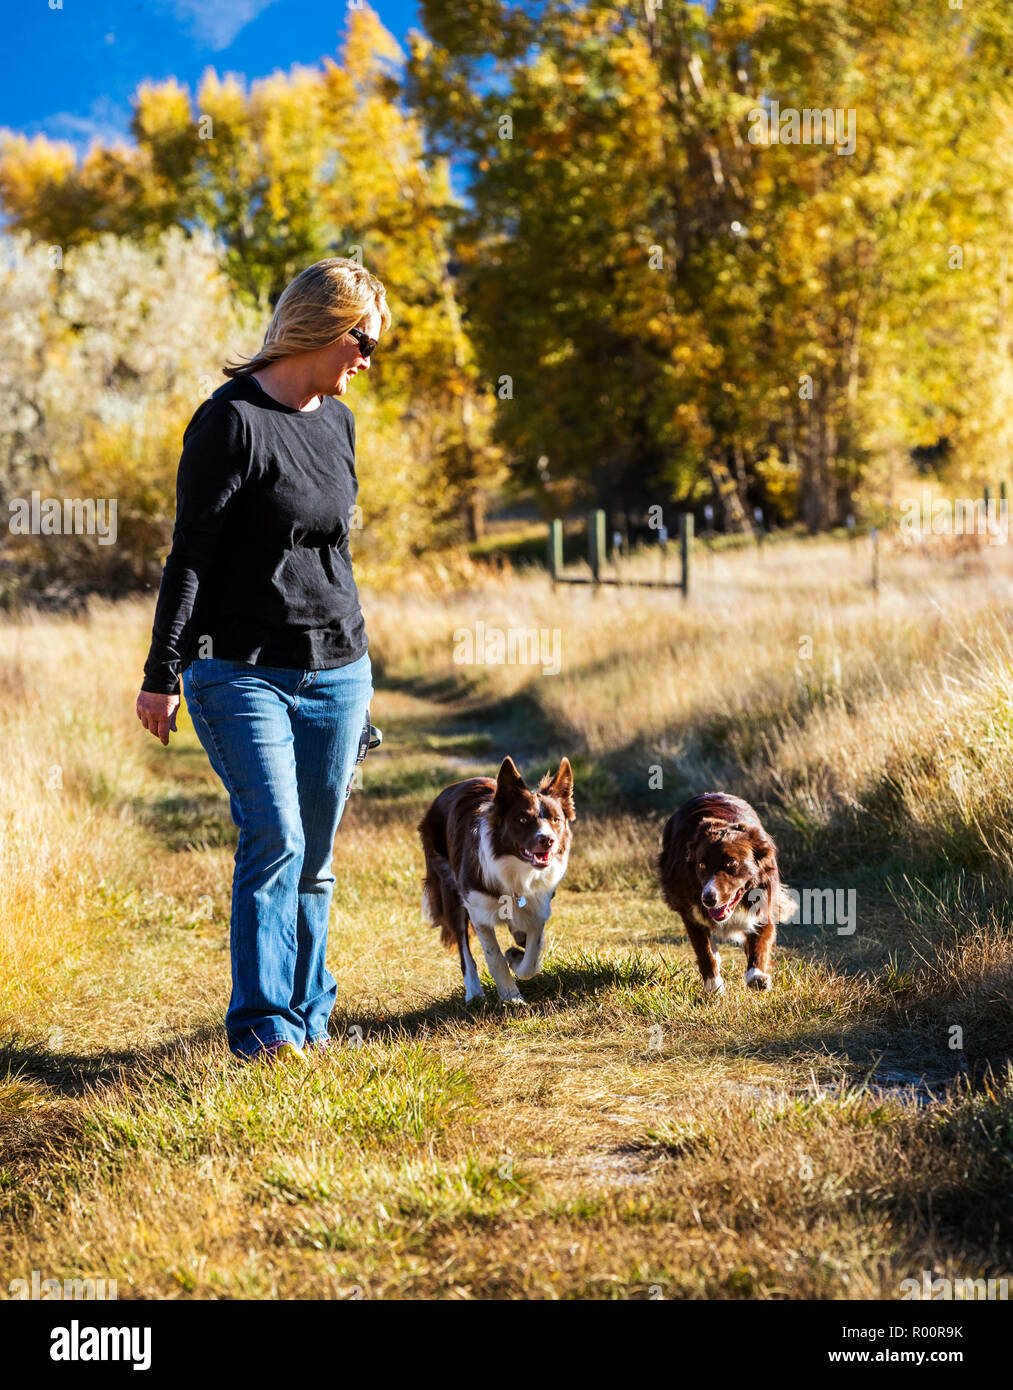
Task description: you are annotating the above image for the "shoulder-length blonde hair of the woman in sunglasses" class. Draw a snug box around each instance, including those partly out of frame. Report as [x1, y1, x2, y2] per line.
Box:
[222, 256, 390, 377]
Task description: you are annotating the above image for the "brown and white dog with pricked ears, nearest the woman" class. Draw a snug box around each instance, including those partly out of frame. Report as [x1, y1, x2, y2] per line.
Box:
[418, 758, 577, 1005]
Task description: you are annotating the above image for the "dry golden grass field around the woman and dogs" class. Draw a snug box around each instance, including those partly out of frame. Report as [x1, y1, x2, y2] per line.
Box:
[0, 542, 1013, 1298]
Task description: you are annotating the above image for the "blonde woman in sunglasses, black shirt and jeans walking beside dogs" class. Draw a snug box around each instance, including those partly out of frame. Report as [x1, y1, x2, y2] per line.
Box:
[138, 257, 390, 1062]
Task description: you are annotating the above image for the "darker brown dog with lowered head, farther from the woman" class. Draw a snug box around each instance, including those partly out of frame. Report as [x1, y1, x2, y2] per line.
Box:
[657, 791, 795, 994]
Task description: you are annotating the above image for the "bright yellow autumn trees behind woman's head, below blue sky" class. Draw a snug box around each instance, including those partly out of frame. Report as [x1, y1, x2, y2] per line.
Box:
[0, 7, 500, 535]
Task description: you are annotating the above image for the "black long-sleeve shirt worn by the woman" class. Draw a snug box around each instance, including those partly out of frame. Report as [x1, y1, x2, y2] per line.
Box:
[140, 377, 368, 695]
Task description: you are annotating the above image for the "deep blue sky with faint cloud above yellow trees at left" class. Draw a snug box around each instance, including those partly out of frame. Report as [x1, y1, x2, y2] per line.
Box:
[0, 0, 421, 152]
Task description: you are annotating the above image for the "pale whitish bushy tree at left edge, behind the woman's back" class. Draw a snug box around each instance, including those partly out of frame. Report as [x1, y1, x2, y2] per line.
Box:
[0, 228, 250, 588]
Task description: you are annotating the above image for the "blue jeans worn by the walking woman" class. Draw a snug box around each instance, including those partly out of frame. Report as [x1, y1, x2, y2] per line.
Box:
[183, 652, 372, 1058]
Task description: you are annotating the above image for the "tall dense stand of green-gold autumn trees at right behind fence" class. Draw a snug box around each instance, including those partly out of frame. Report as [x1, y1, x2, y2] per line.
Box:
[409, 0, 1010, 527]
